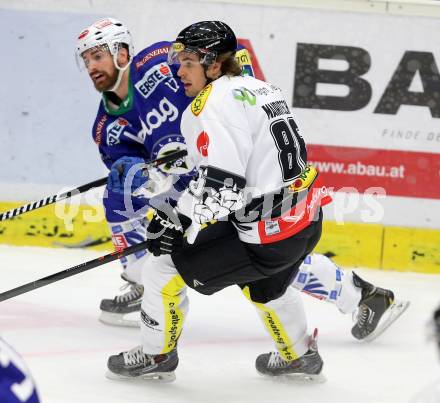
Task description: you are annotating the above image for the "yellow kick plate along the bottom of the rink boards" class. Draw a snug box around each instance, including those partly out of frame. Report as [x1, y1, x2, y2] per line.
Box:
[0, 203, 440, 274]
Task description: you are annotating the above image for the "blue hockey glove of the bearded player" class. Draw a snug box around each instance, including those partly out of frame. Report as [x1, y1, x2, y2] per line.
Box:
[107, 157, 148, 194]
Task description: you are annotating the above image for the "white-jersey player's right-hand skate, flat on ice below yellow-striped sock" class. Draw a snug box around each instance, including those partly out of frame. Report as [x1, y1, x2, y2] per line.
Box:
[255, 330, 325, 382]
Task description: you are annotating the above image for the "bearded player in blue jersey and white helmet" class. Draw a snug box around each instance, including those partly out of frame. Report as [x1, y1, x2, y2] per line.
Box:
[76, 18, 190, 326]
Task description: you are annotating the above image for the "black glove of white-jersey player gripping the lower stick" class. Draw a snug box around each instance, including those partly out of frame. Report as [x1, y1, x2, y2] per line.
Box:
[147, 206, 191, 256]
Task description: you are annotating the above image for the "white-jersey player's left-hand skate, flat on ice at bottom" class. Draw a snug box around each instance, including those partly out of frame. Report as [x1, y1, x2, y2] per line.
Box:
[106, 346, 179, 382]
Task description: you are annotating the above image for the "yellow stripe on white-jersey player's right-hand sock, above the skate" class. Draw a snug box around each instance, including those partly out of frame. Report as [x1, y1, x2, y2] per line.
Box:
[242, 287, 298, 361]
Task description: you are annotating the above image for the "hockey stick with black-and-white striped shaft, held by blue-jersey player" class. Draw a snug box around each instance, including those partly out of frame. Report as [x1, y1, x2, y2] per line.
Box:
[0, 150, 187, 221]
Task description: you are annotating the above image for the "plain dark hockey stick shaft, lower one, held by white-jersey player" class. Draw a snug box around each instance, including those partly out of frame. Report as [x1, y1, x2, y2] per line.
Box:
[0, 241, 147, 302]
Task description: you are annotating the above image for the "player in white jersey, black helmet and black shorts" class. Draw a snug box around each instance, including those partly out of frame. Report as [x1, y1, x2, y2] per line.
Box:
[108, 21, 330, 380]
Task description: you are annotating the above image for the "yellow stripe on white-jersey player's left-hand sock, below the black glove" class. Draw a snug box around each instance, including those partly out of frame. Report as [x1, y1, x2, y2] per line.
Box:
[162, 274, 185, 354]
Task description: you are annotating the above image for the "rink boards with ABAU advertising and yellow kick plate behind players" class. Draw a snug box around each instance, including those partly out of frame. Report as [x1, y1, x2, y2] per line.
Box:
[0, 0, 440, 273]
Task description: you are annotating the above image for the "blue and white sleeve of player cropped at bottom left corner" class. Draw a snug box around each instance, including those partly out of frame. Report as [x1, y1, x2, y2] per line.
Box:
[0, 337, 39, 403]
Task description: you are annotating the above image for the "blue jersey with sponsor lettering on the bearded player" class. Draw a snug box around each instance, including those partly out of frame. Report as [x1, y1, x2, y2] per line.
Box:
[93, 42, 191, 168]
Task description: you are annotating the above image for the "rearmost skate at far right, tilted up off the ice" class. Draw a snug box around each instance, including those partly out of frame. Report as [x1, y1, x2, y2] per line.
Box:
[351, 273, 409, 341]
